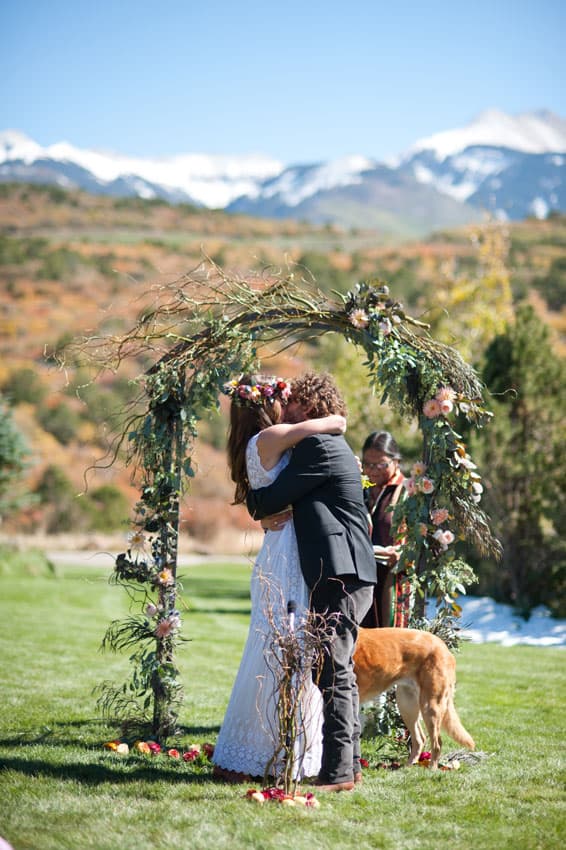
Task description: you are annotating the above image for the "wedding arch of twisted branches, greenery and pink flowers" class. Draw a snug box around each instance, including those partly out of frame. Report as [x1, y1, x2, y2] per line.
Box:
[75, 261, 498, 741]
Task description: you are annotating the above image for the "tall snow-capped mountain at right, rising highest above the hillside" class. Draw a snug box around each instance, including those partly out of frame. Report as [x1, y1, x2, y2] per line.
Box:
[229, 110, 566, 232]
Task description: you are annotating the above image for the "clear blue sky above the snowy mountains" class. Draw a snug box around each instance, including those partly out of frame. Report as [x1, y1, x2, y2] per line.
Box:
[0, 0, 566, 163]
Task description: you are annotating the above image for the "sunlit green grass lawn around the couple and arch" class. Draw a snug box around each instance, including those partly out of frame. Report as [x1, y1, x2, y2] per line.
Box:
[0, 564, 566, 850]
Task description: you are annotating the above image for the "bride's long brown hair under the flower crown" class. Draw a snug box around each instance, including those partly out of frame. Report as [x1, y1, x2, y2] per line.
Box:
[227, 375, 283, 505]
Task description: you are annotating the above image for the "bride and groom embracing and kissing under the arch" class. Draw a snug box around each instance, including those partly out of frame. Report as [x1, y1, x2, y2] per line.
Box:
[213, 373, 376, 791]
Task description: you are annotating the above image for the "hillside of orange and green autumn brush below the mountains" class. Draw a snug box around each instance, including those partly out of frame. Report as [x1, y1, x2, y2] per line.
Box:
[0, 184, 566, 550]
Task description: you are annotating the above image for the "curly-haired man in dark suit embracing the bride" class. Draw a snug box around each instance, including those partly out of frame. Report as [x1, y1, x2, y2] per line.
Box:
[247, 373, 376, 791]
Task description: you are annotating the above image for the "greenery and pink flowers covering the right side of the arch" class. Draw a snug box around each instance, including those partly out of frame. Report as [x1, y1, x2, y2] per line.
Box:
[344, 281, 500, 618]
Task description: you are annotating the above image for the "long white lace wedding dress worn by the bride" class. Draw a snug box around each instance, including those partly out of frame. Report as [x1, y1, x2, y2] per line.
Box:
[213, 435, 322, 779]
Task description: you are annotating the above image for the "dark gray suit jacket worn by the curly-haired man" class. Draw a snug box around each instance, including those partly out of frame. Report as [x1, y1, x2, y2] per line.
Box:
[247, 434, 376, 588]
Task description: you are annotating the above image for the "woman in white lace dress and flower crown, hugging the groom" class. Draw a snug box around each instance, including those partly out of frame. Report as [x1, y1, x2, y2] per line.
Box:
[213, 375, 346, 781]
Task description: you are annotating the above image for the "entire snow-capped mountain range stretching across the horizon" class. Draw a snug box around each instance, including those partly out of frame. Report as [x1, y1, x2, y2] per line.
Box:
[0, 110, 566, 235]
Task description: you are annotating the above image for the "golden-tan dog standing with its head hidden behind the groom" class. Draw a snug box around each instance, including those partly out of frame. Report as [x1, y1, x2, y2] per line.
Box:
[354, 629, 475, 768]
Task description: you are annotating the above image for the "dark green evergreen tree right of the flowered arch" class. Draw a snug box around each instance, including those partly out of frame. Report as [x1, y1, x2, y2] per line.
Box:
[473, 306, 566, 616]
